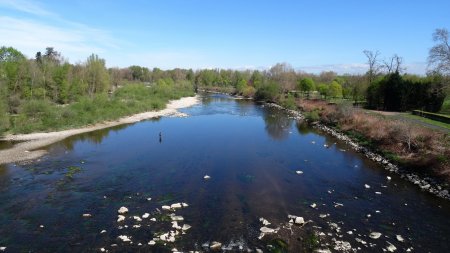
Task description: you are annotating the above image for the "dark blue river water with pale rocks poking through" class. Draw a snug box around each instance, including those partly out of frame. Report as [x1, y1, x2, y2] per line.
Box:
[0, 96, 450, 252]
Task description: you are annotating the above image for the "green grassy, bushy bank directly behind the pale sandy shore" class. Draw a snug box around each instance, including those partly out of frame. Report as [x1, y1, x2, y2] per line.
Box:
[4, 82, 194, 134]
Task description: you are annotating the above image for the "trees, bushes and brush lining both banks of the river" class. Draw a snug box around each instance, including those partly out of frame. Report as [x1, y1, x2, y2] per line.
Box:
[0, 29, 450, 179]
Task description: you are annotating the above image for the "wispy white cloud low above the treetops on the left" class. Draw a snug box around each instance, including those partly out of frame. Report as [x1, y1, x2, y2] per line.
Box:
[0, 0, 119, 62]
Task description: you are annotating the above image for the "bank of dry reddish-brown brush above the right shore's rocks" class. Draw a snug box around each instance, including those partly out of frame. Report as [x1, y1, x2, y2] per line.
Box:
[298, 100, 450, 180]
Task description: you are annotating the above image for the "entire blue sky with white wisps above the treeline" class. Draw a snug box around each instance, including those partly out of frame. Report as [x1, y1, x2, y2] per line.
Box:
[0, 0, 450, 74]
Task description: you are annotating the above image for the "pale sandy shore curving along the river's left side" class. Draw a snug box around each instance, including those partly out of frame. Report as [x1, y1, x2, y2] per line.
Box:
[0, 96, 199, 164]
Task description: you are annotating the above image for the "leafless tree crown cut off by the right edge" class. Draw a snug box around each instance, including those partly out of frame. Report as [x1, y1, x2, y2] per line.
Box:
[428, 29, 450, 75]
